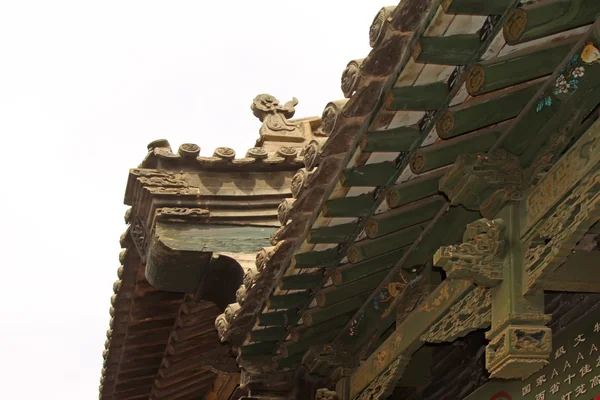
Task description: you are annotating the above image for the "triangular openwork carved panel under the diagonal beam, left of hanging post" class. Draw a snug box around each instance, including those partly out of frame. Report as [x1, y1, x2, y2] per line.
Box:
[421, 286, 492, 343]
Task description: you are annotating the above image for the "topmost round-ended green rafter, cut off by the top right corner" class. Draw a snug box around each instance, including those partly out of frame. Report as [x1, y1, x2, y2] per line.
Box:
[504, 0, 600, 45]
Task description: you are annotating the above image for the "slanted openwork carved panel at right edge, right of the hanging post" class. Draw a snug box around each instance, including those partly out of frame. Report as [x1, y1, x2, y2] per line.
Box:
[524, 169, 600, 293]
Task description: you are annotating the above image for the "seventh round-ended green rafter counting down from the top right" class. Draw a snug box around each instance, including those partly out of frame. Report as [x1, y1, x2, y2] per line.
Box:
[346, 224, 424, 264]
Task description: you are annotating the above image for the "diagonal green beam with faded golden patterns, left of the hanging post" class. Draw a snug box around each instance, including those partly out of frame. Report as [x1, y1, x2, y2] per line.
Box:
[349, 280, 473, 399]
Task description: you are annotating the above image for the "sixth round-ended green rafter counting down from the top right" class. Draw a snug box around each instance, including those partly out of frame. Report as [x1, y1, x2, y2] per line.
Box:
[365, 195, 447, 239]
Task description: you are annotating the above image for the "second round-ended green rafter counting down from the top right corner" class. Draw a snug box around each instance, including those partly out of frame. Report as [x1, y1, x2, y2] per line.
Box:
[466, 39, 577, 96]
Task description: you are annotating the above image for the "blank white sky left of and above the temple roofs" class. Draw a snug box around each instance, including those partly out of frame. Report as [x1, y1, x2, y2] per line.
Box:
[0, 0, 378, 400]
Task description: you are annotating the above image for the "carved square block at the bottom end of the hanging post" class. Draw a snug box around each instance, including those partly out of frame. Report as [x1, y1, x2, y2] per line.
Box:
[486, 325, 552, 379]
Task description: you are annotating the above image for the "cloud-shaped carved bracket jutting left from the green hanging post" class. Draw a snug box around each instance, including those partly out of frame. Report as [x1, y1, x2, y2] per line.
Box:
[433, 218, 505, 287]
